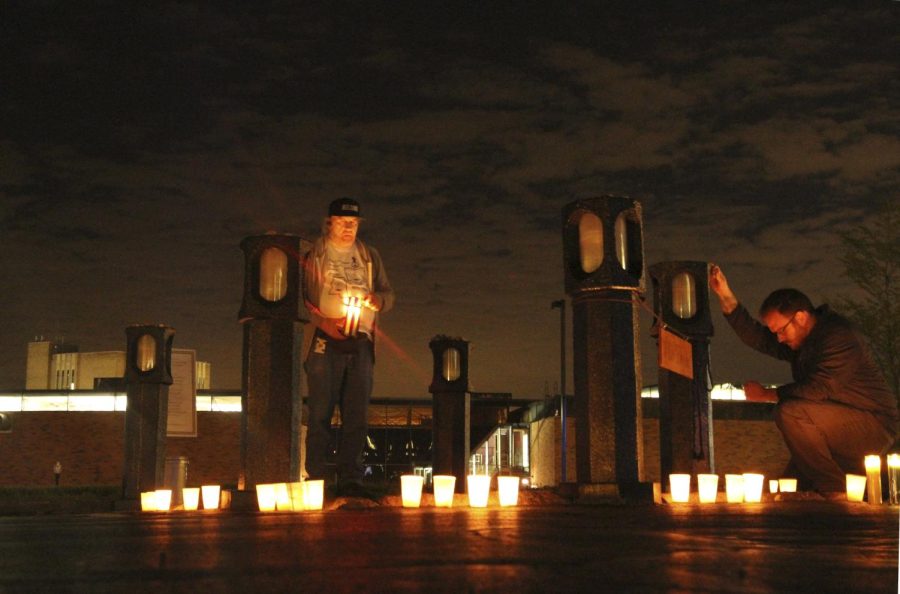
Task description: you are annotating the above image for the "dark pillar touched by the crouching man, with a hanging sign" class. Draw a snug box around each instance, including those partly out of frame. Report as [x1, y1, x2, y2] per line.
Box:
[649, 261, 715, 476]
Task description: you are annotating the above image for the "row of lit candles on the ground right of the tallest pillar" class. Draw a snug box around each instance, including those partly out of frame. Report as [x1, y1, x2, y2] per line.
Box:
[669, 454, 900, 505]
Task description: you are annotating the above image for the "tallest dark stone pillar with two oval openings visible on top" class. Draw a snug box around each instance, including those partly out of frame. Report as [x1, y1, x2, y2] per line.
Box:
[562, 196, 649, 498]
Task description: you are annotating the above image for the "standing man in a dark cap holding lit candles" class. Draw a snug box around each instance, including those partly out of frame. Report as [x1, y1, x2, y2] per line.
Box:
[303, 198, 394, 496]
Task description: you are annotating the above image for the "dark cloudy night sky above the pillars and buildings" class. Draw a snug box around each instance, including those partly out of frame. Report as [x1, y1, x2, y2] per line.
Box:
[0, 0, 900, 397]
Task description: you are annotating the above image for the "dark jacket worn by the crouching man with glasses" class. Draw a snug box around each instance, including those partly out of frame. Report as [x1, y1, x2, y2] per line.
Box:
[725, 305, 898, 437]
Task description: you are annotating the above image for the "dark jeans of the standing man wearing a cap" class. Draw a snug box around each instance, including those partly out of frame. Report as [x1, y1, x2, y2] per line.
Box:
[304, 331, 375, 482]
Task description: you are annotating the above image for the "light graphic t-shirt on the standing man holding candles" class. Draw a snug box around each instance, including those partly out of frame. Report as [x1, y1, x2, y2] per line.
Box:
[319, 242, 375, 336]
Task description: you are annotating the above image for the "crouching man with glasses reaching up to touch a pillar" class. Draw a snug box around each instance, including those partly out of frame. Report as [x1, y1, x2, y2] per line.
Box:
[709, 265, 898, 499]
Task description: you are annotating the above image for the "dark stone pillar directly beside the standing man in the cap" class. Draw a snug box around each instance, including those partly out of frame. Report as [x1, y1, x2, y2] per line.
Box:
[238, 233, 309, 491]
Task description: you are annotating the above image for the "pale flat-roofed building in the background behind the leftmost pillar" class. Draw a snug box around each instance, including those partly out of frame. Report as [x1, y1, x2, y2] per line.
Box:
[25, 337, 212, 390]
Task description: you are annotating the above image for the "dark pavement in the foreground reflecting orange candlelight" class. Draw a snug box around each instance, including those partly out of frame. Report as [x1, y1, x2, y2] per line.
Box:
[0, 502, 898, 592]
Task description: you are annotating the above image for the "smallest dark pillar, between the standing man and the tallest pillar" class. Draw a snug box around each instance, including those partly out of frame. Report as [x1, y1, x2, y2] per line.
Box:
[428, 335, 471, 493]
